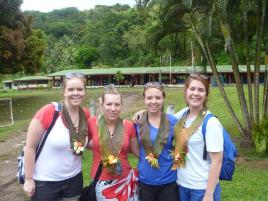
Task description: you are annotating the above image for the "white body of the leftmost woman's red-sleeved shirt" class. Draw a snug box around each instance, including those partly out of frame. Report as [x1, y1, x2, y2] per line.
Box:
[34, 115, 82, 181]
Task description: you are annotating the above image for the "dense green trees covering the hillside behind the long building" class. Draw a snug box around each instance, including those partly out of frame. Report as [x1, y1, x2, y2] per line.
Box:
[0, 0, 268, 74]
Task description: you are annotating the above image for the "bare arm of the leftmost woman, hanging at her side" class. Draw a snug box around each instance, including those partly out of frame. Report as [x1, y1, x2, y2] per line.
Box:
[23, 119, 45, 197]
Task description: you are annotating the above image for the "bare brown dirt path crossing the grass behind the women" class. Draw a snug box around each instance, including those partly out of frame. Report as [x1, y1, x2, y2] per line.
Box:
[0, 93, 140, 201]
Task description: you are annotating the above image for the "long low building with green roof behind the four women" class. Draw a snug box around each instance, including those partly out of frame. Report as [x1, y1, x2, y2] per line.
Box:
[48, 65, 265, 87]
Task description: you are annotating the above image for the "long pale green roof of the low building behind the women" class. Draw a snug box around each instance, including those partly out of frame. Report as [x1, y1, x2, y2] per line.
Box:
[48, 65, 265, 77]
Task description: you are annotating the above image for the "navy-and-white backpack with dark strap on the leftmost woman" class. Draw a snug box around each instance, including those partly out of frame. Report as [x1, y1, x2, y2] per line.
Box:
[17, 102, 61, 184]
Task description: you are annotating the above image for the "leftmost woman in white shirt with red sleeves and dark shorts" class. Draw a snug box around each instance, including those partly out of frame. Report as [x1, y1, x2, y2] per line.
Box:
[23, 73, 90, 201]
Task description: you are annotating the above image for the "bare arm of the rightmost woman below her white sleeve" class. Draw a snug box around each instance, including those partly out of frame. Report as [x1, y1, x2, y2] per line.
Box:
[203, 152, 223, 201]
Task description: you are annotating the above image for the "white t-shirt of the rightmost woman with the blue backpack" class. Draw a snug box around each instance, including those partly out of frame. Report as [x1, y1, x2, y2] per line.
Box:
[175, 108, 223, 189]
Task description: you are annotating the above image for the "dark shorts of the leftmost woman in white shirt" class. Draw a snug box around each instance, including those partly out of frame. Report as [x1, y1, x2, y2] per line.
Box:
[31, 172, 83, 201]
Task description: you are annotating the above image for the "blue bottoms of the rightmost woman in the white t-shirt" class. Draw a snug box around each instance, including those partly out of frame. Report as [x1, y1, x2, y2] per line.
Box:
[179, 183, 221, 201]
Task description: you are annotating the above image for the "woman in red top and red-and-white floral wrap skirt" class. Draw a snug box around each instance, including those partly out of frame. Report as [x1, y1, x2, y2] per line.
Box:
[89, 85, 139, 201]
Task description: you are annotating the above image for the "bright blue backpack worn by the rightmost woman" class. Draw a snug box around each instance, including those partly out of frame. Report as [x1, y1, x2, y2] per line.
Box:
[202, 113, 238, 181]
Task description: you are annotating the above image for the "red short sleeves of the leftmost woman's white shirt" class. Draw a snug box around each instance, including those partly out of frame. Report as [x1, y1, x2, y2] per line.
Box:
[33, 103, 90, 130]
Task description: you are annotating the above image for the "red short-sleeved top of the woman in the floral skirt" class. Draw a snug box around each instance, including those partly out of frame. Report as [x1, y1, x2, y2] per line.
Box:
[88, 117, 136, 180]
